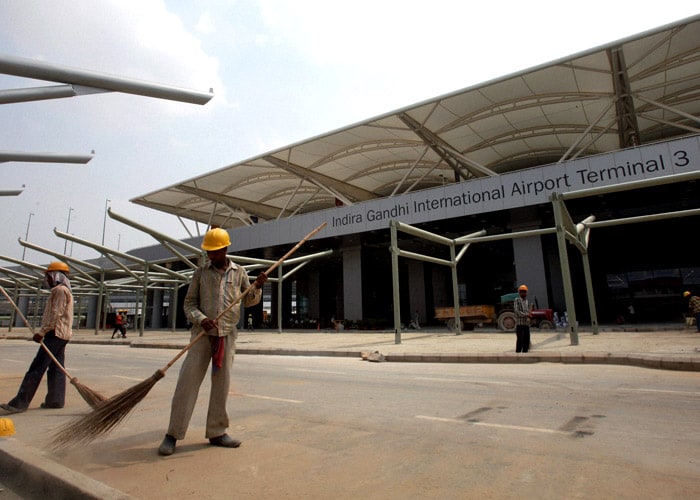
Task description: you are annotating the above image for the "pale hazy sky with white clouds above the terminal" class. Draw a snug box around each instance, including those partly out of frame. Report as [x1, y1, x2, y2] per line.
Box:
[0, 0, 698, 266]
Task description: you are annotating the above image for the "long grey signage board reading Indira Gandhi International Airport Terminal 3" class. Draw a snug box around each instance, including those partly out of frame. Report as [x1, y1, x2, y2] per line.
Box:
[232, 136, 700, 252]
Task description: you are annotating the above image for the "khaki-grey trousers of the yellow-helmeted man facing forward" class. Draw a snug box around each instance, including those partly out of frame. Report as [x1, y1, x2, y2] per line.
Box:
[168, 333, 236, 439]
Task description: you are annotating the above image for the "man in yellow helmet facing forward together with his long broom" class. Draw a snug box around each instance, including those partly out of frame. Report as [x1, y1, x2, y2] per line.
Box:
[51, 222, 327, 455]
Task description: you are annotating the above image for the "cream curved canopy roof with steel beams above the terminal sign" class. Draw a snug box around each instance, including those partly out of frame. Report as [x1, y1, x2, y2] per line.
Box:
[131, 16, 700, 228]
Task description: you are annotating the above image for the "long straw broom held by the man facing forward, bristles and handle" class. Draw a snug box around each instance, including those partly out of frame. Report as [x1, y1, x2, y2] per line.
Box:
[50, 222, 326, 449]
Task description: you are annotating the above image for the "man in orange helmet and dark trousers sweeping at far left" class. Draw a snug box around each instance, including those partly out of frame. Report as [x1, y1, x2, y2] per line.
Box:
[0, 261, 73, 415]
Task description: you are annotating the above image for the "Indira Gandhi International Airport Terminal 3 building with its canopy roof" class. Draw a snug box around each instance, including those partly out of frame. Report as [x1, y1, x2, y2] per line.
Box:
[4, 16, 700, 336]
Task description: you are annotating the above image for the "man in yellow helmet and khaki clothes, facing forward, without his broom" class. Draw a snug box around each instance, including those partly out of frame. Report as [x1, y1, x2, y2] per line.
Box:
[158, 228, 267, 455]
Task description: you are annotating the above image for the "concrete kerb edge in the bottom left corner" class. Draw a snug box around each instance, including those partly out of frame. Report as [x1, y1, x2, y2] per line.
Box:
[0, 438, 133, 500]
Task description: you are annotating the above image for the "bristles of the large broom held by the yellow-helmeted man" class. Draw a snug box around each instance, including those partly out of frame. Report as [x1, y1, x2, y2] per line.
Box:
[51, 370, 165, 449]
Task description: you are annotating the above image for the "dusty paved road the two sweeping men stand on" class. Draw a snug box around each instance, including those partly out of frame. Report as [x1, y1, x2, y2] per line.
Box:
[0, 337, 700, 498]
